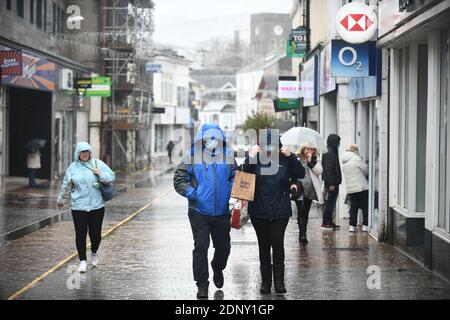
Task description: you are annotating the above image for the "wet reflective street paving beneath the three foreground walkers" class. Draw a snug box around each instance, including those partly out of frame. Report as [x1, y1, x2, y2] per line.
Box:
[0, 174, 450, 300]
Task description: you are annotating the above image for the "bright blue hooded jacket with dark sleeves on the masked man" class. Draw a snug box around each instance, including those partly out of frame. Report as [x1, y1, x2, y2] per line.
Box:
[173, 124, 236, 216]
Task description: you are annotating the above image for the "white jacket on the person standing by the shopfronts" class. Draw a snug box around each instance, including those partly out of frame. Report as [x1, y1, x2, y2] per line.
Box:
[341, 151, 369, 194]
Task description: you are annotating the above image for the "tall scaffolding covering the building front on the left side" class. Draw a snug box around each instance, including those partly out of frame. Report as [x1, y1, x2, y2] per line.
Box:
[101, 0, 154, 170]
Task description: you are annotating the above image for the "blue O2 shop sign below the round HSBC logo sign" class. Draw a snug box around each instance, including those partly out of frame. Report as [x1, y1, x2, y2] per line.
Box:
[331, 40, 376, 77]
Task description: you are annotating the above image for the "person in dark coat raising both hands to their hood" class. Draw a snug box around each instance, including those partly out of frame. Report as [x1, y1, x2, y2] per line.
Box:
[243, 129, 305, 293]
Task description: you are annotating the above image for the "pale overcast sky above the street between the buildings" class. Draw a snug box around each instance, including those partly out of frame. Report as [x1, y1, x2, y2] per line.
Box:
[154, 0, 292, 47]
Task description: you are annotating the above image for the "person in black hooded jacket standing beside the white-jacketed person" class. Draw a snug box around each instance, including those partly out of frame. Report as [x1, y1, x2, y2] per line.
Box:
[321, 134, 342, 230]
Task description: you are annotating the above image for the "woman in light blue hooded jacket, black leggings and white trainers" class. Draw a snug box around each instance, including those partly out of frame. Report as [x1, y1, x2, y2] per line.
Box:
[57, 142, 116, 273]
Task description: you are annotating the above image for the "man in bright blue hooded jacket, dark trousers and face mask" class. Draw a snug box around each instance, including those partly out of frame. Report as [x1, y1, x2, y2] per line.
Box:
[173, 124, 236, 298]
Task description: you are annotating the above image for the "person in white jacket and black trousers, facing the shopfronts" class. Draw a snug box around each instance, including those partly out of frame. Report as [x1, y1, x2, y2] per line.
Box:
[342, 144, 369, 232]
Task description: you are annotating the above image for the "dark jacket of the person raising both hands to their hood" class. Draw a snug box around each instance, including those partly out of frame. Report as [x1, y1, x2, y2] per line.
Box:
[243, 130, 305, 219]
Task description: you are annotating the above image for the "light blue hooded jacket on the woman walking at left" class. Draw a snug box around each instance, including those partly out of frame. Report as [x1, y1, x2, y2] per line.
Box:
[57, 142, 116, 212]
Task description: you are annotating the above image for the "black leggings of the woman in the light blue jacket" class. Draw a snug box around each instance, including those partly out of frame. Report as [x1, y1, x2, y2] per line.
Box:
[72, 208, 105, 261]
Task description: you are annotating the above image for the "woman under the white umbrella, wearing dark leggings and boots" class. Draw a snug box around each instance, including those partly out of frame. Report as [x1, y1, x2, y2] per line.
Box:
[291, 141, 323, 244]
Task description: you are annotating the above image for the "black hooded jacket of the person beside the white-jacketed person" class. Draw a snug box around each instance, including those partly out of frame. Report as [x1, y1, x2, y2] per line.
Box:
[322, 134, 342, 187]
